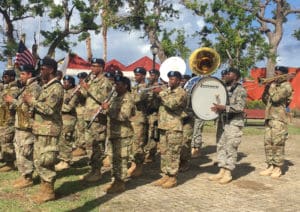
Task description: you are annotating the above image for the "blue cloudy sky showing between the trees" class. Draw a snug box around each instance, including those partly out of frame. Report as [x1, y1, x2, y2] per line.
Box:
[0, 0, 300, 76]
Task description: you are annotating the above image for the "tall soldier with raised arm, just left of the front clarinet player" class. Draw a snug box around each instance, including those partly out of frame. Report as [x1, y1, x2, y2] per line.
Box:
[80, 58, 113, 182]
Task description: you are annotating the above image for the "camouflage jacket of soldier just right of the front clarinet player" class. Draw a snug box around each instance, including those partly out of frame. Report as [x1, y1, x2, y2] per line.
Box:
[131, 83, 148, 123]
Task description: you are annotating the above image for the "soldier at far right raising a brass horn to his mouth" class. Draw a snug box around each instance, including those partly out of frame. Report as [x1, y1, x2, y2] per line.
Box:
[260, 66, 293, 178]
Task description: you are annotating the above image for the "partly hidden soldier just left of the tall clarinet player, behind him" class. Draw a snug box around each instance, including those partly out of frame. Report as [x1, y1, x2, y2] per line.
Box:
[72, 72, 88, 157]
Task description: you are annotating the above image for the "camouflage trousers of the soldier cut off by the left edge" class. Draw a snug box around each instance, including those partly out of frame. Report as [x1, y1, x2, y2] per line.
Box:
[0, 126, 16, 163]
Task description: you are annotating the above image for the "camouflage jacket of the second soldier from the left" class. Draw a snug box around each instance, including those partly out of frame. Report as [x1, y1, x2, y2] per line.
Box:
[12, 77, 41, 130]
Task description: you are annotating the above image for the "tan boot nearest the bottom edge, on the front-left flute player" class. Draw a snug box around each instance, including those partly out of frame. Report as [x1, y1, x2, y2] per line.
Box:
[31, 181, 55, 204]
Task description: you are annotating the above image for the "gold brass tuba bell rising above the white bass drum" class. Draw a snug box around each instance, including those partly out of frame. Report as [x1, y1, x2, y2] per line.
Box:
[189, 47, 221, 75]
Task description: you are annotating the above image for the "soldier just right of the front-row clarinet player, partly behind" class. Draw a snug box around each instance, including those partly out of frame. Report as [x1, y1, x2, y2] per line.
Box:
[128, 67, 148, 177]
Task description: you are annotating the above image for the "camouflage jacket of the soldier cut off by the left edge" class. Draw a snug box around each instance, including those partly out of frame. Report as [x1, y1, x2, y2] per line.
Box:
[0, 80, 20, 127]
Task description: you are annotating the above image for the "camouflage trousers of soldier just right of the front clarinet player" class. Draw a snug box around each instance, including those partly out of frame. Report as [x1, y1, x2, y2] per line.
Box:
[131, 122, 147, 164]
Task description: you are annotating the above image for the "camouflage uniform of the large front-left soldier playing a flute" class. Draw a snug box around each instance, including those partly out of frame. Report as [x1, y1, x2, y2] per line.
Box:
[29, 78, 64, 183]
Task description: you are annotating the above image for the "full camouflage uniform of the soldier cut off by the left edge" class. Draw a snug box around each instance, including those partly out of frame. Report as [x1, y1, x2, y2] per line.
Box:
[0, 81, 20, 163]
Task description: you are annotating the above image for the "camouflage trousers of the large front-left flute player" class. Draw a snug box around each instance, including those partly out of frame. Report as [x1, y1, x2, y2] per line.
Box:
[33, 135, 59, 183]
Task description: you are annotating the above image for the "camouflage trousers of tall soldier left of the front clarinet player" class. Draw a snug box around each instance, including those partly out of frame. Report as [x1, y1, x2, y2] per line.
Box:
[84, 122, 106, 170]
